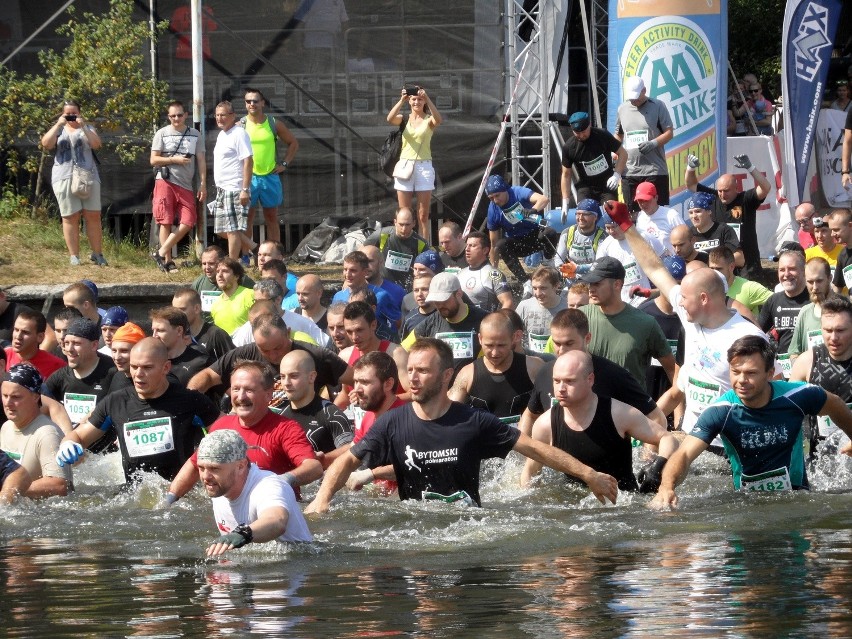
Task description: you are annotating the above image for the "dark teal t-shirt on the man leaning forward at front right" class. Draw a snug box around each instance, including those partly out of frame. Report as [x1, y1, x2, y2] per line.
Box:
[692, 382, 827, 490]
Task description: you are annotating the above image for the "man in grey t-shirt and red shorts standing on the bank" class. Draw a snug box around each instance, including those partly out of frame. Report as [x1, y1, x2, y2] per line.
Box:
[151, 100, 207, 273]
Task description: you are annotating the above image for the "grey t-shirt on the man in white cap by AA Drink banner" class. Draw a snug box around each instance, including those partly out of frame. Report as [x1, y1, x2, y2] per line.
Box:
[615, 98, 674, 177]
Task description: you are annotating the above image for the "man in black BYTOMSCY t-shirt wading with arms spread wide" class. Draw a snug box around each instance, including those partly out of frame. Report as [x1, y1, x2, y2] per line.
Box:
[305, 338, 618, 513]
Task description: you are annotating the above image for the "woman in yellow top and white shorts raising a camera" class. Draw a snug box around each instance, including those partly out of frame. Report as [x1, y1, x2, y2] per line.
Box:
[387, 86, 443, 246]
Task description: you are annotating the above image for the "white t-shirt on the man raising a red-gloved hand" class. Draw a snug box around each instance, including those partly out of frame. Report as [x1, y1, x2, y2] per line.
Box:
[669, 286, 781, 443]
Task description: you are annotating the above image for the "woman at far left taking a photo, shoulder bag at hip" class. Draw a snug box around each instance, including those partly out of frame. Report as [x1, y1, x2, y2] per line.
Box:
[41, 100, 107, 266]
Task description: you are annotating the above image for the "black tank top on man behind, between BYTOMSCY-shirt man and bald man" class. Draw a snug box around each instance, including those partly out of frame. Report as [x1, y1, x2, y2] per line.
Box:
[468, 353, 533, 417]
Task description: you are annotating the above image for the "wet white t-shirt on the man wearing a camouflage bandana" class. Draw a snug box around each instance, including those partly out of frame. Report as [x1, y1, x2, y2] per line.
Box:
[211, 464, 314, 541]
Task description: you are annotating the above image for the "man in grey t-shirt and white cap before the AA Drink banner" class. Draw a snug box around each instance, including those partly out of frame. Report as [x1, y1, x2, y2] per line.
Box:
[615, 76, 674, 212]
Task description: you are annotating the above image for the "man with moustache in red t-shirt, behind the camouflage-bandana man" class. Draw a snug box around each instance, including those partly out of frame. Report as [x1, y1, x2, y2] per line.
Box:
[165, 356, 322, 505]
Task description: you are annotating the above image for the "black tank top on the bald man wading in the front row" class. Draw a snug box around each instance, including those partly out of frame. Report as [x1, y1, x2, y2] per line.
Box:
[550, 395, 638, 490]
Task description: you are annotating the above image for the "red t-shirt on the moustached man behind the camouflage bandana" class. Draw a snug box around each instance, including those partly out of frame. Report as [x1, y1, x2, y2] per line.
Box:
[191, 411, 317, 499]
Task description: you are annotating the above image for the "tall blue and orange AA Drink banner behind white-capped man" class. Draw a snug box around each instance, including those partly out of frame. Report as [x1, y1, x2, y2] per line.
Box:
[607, 0, 728, 204]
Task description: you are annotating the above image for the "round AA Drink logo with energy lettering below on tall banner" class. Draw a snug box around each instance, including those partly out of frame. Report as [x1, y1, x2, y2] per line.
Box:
[621, 15, 719, 193]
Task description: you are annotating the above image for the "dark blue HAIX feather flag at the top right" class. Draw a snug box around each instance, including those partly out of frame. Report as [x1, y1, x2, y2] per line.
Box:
[781, 0, 841, 209]
